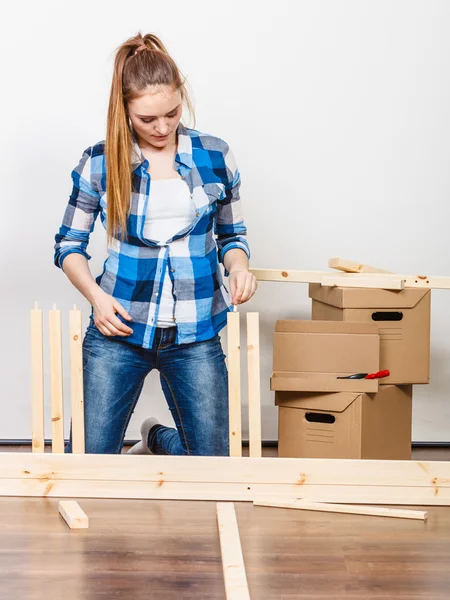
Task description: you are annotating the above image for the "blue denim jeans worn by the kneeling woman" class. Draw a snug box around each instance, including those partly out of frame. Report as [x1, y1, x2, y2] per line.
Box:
[66, 322, 229, 456]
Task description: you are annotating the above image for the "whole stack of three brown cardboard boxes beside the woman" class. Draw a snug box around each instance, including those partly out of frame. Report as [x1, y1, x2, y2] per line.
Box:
[271, 284, 430, 459]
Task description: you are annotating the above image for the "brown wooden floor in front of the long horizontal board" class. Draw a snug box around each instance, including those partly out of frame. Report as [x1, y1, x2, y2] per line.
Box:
[0, 448, 450, 600]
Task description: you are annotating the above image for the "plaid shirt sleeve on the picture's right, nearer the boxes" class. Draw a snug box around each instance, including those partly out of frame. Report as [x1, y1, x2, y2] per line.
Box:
[215, 146, 250, 264]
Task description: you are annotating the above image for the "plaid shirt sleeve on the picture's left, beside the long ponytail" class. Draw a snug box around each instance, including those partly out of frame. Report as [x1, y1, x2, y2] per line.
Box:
[54, 148, 100, 268]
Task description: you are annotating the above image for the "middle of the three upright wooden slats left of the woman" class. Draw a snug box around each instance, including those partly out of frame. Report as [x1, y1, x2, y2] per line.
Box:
[48, 305, 64, 452]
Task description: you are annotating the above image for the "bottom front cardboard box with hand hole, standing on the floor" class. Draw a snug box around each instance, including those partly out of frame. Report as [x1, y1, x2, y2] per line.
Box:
[275, 385, 412, 460]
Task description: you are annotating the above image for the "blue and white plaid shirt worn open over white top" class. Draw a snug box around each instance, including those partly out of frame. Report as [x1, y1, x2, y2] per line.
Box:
[55, 124, 250, 348]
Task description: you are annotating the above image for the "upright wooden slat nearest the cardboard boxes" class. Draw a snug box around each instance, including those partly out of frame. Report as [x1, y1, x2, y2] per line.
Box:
[247, 313, 262, 457]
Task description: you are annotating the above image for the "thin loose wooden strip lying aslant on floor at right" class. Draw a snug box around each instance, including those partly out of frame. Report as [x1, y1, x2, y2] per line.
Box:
[253, 499, 427, 521]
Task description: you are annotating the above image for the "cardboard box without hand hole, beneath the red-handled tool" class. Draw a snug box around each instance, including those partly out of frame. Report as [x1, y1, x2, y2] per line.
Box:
[271, 320, 380, 392]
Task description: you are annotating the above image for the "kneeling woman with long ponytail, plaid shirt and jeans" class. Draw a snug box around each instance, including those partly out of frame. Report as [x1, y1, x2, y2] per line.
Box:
[55, 34, 257, 455]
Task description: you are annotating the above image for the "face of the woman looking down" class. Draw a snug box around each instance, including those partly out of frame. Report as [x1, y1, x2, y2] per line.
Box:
[128, 85, 183, 149]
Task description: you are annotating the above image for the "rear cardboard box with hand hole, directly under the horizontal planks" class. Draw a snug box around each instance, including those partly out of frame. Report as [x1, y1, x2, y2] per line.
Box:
[309, 283, 431, 384]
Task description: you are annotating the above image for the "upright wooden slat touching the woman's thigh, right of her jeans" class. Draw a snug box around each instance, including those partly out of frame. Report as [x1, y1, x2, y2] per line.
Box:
[227, 312, 242, 456]
